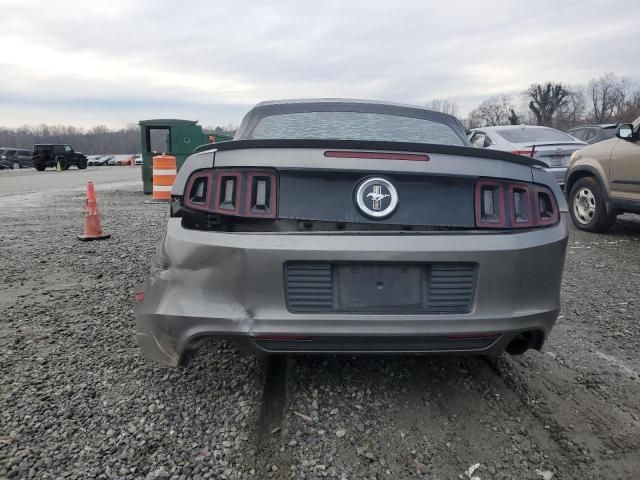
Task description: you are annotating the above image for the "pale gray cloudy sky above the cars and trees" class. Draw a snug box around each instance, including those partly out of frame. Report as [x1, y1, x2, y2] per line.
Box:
[0, 0, 640, 127]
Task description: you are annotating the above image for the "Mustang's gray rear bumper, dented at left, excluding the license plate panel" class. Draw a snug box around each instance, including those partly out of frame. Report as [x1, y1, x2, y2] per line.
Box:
[136, 215, 568, 366]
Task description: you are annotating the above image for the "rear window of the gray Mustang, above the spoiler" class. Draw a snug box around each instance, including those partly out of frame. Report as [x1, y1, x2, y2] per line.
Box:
[250, 112, 464, 145]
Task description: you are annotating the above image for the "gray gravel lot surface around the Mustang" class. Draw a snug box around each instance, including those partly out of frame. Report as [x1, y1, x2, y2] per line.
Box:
[0, 169, 640, 480]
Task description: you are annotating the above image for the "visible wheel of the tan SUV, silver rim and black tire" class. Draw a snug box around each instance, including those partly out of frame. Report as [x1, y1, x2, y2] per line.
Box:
[569, 177, 616, 233]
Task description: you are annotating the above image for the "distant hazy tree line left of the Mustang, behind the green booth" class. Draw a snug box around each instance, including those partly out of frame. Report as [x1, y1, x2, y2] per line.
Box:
[0, 124, 234, 155]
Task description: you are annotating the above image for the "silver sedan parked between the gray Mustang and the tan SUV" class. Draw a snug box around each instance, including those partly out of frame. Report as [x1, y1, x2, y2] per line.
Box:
[470, 125, 586, 186]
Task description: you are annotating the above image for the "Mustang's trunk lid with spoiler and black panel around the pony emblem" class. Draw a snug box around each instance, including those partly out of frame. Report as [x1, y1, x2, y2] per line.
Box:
[178, 140, 544, 230]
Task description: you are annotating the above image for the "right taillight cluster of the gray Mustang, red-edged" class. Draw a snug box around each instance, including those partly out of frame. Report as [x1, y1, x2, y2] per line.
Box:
[475, 179, 559, 228]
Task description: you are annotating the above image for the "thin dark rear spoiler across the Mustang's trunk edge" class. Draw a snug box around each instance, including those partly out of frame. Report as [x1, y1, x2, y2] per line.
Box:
[194, 139, 547, 168]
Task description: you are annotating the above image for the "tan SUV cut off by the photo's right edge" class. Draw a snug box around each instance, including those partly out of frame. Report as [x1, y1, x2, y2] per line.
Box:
[565, 118, 640, 232]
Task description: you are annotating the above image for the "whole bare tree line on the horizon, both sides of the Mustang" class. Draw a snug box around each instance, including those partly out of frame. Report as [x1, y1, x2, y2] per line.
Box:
[0, 73, 640, 155]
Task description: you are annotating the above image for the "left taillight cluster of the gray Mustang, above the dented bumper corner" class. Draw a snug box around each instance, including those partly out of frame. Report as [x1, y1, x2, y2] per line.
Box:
[184, 169, 278, 218]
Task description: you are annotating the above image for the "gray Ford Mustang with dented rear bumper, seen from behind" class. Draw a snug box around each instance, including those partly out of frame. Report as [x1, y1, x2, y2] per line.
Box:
[136, 100, 567, 366]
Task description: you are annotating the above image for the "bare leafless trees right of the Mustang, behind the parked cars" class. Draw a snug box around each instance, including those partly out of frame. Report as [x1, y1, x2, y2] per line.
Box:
[427, 73, 640, 130]
